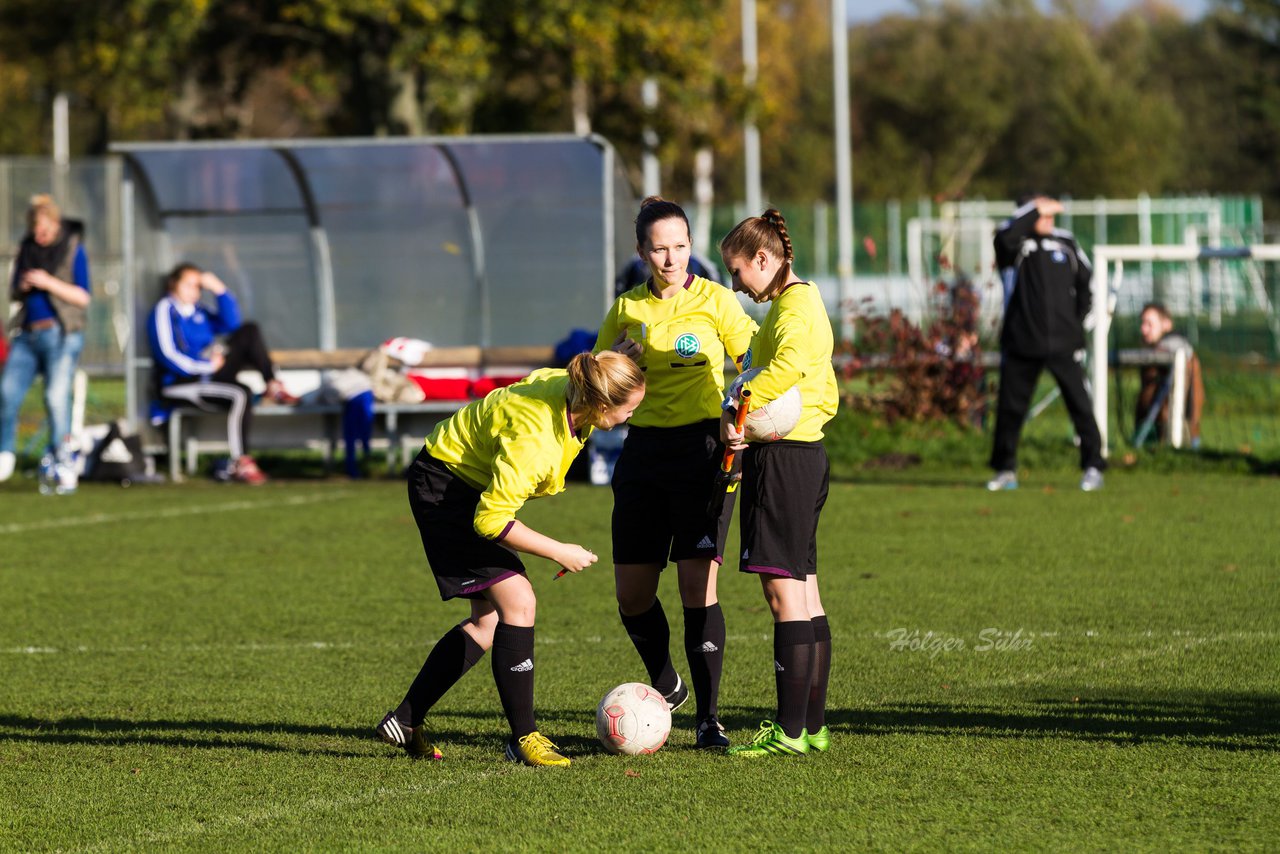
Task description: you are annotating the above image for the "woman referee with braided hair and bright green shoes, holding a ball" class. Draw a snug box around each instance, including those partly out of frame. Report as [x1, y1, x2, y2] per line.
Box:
[721, 209, 840, 757]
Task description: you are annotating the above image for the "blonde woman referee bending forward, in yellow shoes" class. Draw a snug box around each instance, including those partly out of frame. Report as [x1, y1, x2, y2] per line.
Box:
[376, 352, 645, 766]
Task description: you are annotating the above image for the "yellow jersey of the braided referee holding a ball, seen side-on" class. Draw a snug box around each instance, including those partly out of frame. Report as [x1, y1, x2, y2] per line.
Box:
[742, 282, 840, 442]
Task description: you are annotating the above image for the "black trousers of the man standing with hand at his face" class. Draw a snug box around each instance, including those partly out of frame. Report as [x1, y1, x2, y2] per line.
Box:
[991, 351, 1106, 471]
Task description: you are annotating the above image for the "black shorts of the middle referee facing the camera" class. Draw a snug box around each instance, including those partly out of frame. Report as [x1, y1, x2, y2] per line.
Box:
[613, 419, 741, 566]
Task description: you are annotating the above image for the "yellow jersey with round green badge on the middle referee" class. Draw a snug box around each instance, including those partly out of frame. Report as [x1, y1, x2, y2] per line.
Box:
[595, 275, 756, 426]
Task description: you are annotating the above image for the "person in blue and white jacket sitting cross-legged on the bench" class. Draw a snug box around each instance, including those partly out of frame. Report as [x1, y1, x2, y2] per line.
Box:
[147, 264, 297, 485]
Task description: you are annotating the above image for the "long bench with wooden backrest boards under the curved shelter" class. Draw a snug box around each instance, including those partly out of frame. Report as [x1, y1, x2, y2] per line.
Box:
[166, 347, 554, 481]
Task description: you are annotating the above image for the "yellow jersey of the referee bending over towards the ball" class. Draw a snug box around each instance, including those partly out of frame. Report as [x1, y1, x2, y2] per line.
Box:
[426, 367, 591, 540]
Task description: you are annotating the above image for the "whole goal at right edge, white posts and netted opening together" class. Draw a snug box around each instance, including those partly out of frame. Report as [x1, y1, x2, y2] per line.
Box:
[1088, 245, 1280, 457]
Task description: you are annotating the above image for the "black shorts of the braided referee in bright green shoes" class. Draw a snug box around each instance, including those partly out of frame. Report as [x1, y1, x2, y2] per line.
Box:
[739, 439, 831, 581]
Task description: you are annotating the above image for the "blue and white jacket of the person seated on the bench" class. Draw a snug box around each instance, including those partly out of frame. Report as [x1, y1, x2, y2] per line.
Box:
[147, 291, 241, 388]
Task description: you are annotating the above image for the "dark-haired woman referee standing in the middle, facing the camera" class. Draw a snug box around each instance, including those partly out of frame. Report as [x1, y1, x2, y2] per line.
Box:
[595, 196, 755, 748]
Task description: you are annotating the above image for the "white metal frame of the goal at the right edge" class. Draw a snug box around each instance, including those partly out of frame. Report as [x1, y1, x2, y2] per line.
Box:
[1089, 245, 1280, 457]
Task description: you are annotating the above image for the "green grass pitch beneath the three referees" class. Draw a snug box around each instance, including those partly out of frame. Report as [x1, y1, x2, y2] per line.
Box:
[0, 470, 1280, 851]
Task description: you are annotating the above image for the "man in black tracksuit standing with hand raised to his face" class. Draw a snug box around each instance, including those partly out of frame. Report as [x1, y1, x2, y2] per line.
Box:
[987, 196, 1106, 492]
